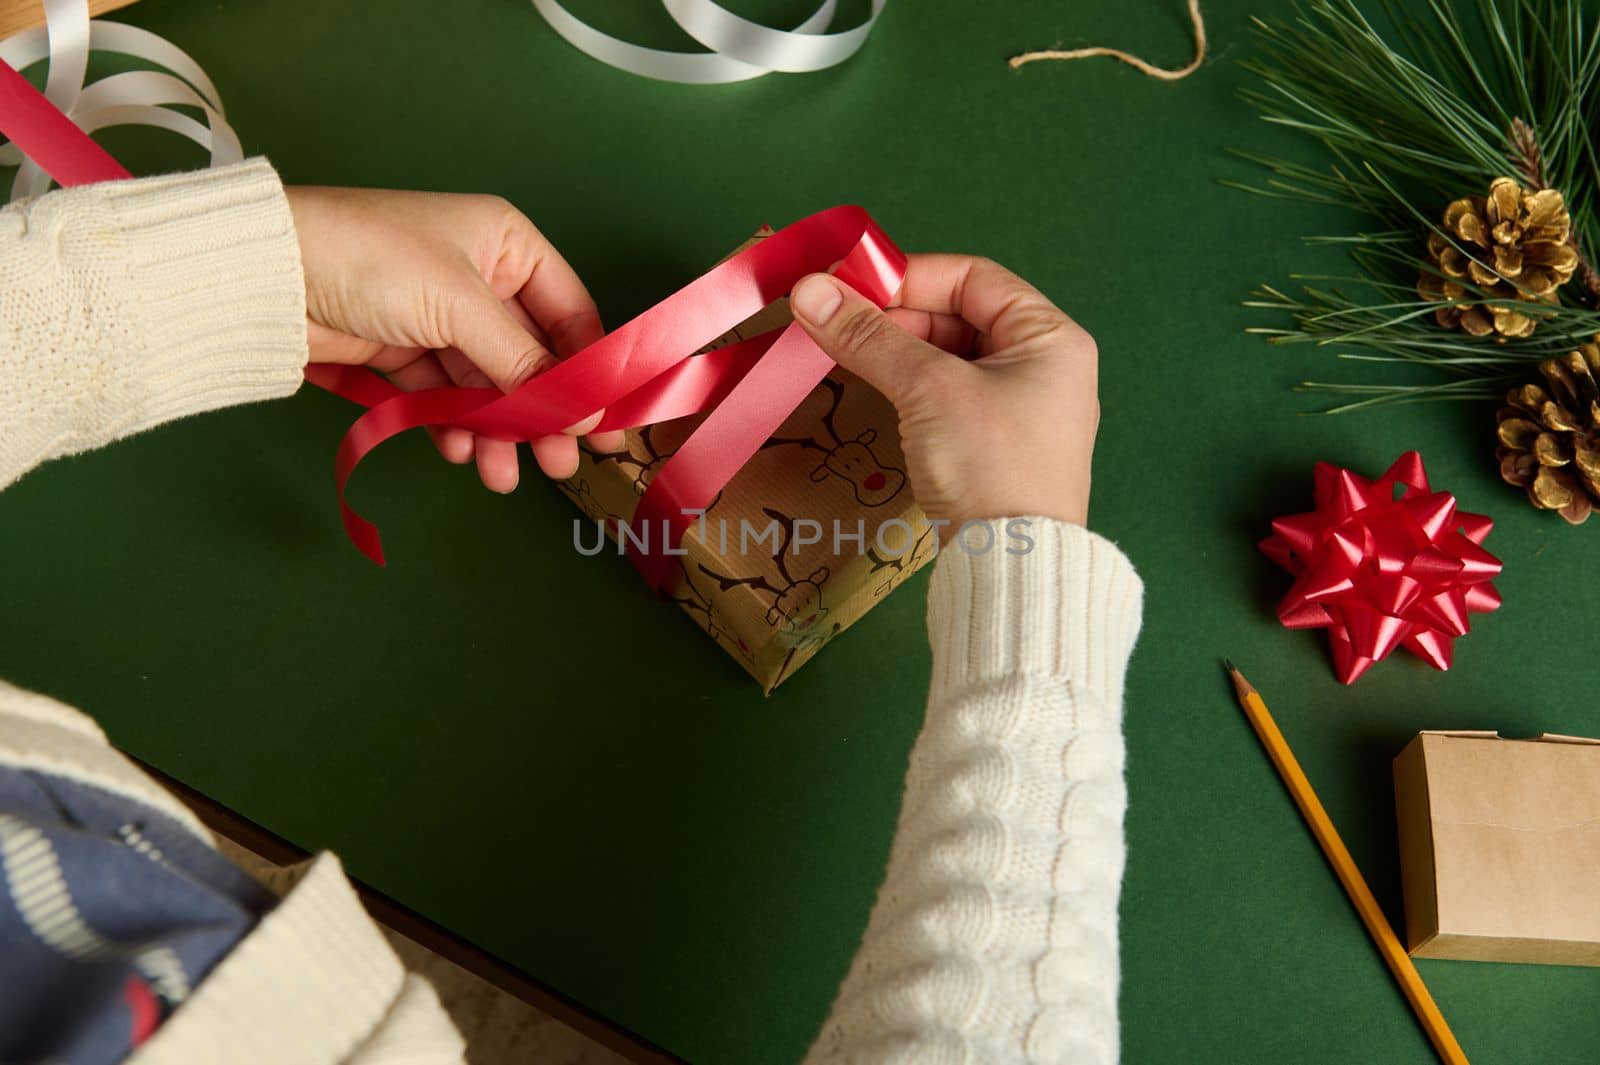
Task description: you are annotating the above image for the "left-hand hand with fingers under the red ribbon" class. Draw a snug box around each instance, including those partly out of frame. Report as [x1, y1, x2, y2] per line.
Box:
[288, 187, 622, 493]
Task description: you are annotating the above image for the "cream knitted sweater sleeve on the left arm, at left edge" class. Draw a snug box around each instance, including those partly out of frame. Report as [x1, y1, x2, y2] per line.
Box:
[0, 160, 306, 488]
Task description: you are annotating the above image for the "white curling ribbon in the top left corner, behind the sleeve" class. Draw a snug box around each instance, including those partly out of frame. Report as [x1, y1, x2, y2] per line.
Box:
[0, 0, 245, 200]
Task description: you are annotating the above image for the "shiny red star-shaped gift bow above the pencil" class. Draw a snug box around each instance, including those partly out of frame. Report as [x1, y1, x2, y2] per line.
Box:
[1261, 451, 1501, 684]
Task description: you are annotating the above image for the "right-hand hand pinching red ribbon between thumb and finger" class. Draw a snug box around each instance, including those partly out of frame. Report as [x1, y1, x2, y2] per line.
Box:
[790, 256, 1099, 537]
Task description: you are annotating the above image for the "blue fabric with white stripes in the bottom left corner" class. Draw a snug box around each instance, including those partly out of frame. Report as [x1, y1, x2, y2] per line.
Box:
[0, 766, 274, 1065]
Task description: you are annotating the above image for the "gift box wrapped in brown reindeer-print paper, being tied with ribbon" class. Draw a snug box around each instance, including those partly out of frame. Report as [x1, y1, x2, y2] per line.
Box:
[560, 229, 938, 692]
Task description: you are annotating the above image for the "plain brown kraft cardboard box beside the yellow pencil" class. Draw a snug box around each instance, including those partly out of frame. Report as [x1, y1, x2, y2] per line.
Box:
[1394, 732, 1600, 966]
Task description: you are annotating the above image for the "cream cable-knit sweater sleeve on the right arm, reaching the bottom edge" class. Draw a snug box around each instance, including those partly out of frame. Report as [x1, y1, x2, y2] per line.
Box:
[806, 518, 1142, 1065]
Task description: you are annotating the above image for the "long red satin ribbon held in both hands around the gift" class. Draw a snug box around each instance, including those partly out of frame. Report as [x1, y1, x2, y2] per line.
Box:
[0, 53, 906, 590]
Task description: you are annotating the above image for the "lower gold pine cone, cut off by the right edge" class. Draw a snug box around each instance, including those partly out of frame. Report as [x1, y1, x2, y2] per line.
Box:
[1494, 336, 1600, 525]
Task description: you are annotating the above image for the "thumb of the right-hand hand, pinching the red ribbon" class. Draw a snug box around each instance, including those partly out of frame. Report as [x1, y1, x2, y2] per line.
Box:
[789, 273, 949, 403]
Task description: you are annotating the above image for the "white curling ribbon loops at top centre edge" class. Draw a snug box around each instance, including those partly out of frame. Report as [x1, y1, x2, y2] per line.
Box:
[533, 0, 888, 85]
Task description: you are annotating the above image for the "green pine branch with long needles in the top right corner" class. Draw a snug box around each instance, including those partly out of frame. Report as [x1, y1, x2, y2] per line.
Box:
[1222, 0, 1600, 413]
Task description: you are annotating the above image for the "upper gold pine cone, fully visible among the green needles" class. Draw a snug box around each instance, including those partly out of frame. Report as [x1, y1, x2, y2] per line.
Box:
[1416, 178, 1578, 341]
